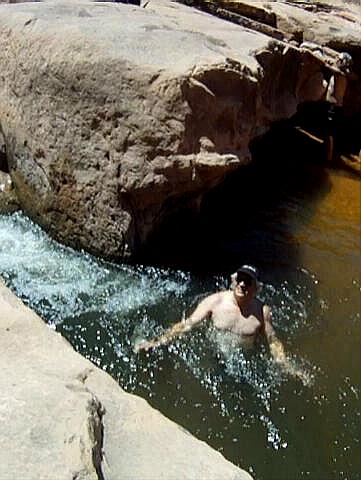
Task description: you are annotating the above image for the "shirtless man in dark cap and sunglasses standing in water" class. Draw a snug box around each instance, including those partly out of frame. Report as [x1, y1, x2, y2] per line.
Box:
[135, 265, 298, 377]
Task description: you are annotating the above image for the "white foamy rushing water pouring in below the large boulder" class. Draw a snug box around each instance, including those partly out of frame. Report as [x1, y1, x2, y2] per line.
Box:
[0, 213, 189, 323]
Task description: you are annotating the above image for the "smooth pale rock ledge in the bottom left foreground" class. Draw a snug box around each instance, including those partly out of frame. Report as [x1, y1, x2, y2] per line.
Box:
[0, 282, 251, 480]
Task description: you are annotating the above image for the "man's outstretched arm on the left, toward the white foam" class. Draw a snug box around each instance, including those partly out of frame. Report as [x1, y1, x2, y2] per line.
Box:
[134, 294, 218, 352]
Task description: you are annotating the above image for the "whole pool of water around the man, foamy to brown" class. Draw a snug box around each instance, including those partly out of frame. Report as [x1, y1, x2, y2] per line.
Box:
[0, 165, 361, 480]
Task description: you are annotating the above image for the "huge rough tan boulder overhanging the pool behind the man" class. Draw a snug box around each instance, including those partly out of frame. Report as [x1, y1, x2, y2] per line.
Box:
[0, 0, 361, 258]
